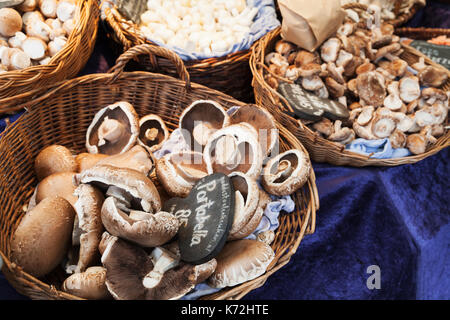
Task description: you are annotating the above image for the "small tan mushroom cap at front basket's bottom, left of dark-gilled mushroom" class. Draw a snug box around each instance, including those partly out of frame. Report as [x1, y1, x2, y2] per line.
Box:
[62, 266, 111, 300]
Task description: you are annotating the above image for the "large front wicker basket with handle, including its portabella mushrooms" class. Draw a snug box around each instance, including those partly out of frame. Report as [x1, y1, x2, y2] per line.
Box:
[0, 44, 319, 299]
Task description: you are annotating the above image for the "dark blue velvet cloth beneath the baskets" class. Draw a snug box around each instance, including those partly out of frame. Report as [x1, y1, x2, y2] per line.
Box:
[0, 1, 450, 300]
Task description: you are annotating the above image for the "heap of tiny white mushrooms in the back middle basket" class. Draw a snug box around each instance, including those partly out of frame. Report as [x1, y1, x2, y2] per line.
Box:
[139, 0, 258, 54]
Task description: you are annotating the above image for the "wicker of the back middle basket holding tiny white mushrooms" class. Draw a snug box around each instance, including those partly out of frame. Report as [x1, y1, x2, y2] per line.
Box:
[105, 2, 278, 102]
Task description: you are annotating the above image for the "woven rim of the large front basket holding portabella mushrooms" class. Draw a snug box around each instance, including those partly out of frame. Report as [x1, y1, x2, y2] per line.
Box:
[0, 43, 319, 299]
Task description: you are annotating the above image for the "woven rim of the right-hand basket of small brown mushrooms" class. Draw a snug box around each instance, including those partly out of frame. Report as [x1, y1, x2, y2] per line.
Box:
[250, 27, 450, 167]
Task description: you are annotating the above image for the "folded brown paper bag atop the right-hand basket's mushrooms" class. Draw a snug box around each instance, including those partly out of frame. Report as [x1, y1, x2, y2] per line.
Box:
[278, 0, 345, 51]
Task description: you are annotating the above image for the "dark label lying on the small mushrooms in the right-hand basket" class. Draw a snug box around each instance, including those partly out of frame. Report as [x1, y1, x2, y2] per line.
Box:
[278, 83, 350, 121]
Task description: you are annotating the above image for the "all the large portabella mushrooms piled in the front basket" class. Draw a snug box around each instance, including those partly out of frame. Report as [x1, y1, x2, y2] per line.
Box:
[11, 100, 311, 299]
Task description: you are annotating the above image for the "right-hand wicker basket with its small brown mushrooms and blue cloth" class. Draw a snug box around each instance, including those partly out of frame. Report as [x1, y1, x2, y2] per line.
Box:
[250, 4, 450, 166]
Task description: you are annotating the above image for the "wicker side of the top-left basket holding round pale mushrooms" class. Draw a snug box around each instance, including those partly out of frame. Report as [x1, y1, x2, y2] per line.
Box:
[0, 0, 100, 114]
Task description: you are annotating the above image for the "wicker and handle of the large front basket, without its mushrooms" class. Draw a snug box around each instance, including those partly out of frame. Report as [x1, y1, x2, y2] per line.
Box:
[0, 44, 319, 299]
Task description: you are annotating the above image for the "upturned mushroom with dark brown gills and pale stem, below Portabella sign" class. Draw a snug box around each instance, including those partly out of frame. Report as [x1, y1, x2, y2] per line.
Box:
[101, 237, 217, 300]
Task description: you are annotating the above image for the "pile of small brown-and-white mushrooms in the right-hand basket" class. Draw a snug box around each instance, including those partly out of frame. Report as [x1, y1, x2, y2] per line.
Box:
[264, 5, 450, 154]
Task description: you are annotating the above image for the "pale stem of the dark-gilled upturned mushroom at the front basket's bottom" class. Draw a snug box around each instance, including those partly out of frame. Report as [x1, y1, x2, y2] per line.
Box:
[142, 247, 179, 288]
